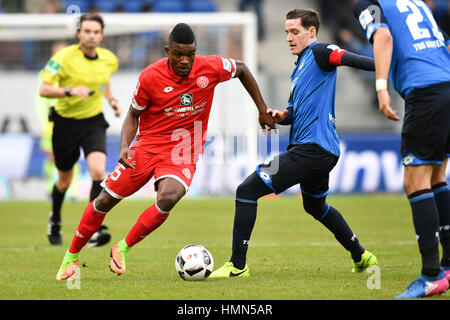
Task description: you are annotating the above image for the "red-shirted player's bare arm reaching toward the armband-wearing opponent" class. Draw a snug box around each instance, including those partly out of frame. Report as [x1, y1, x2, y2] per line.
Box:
[234, 61, 276, 130]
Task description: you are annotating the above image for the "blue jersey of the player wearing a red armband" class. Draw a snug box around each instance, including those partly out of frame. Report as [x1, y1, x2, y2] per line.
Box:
[287, 42, 340, 156]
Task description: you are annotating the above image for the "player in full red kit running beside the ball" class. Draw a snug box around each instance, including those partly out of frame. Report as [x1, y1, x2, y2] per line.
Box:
[56, 23, 275, 280]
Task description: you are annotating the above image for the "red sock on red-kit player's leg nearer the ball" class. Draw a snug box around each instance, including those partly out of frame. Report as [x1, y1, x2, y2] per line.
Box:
[125, 203, 169, 247]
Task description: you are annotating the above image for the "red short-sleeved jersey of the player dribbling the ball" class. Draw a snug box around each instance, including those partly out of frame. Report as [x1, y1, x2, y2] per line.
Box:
[132, 55, 236, 163]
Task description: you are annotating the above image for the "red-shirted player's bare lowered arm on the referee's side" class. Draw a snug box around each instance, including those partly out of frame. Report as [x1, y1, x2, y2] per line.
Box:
[119, 106, 141, 169]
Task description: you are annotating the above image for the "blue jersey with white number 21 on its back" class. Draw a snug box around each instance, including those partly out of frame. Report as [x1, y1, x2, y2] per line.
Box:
[355, 0, 450, 98]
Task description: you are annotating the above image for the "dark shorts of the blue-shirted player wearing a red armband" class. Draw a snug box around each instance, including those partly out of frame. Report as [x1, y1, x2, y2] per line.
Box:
[256, 143, 339, 198]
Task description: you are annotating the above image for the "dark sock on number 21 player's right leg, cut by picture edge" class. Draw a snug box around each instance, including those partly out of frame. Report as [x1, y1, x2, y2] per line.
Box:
[431, 182, 450, 239]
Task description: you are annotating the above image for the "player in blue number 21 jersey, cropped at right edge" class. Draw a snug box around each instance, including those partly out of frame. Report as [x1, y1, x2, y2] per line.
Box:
[354, 0, 450, 298]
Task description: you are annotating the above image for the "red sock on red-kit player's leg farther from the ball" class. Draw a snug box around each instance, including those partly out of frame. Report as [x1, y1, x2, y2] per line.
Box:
[69, 200, 106, 253]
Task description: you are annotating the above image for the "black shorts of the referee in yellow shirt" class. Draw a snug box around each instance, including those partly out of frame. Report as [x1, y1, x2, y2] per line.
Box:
[52, 112, 109, 171]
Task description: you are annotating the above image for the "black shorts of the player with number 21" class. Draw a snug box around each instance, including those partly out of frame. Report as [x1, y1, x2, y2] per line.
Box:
[401, 82, 450, 166]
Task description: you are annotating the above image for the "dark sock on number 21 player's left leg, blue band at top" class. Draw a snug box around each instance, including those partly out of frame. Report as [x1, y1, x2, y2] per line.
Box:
[408, 189, 439, 254]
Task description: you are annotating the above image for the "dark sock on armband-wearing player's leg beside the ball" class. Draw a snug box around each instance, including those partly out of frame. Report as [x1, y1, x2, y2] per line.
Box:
[230, 199, 257, 269]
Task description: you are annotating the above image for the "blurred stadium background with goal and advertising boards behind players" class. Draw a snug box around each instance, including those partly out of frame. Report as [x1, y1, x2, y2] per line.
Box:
[0, 0, 450, 200]
